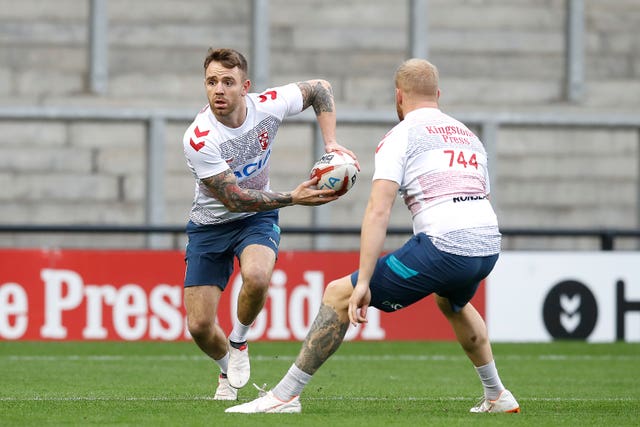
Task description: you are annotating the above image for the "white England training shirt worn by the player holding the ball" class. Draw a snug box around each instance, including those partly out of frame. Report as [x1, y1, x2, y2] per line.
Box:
[183, 83, 302, 224]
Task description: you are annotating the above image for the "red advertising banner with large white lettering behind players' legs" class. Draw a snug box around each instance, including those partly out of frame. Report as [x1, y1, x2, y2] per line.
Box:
[0, 249, 485, 341]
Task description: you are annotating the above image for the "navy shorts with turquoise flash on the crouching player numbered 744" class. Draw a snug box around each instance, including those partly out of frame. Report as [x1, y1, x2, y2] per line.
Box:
[351, 233, 498, 312]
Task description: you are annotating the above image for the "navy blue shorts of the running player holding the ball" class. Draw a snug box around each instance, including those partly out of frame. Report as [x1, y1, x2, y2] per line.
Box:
[184, 210, 280, 290]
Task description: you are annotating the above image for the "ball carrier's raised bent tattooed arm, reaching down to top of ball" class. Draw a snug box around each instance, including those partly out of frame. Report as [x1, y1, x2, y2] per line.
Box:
[297, 79, 360, 165]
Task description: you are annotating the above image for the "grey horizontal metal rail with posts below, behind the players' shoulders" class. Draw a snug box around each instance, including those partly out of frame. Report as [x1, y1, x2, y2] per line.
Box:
[0, 106, 640, 247]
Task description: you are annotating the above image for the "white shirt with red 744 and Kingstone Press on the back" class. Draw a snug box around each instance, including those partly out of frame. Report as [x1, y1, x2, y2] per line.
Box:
[373, 108, 501, 256]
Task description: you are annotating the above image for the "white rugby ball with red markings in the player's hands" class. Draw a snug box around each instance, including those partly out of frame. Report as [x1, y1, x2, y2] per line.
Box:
[309, 151, 358, 196]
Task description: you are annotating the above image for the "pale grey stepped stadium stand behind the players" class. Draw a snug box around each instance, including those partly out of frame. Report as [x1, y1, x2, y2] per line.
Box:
[0, 0, 640, 249]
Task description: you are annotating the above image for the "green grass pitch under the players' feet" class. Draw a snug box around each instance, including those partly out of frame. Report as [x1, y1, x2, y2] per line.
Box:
[0, 341, 640, 427]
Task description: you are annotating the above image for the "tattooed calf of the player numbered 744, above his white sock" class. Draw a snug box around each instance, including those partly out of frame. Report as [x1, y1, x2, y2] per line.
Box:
[295, 303, 349, 375]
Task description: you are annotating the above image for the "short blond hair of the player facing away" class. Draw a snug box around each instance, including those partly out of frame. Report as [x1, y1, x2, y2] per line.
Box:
[395, 58, 439, 98]
